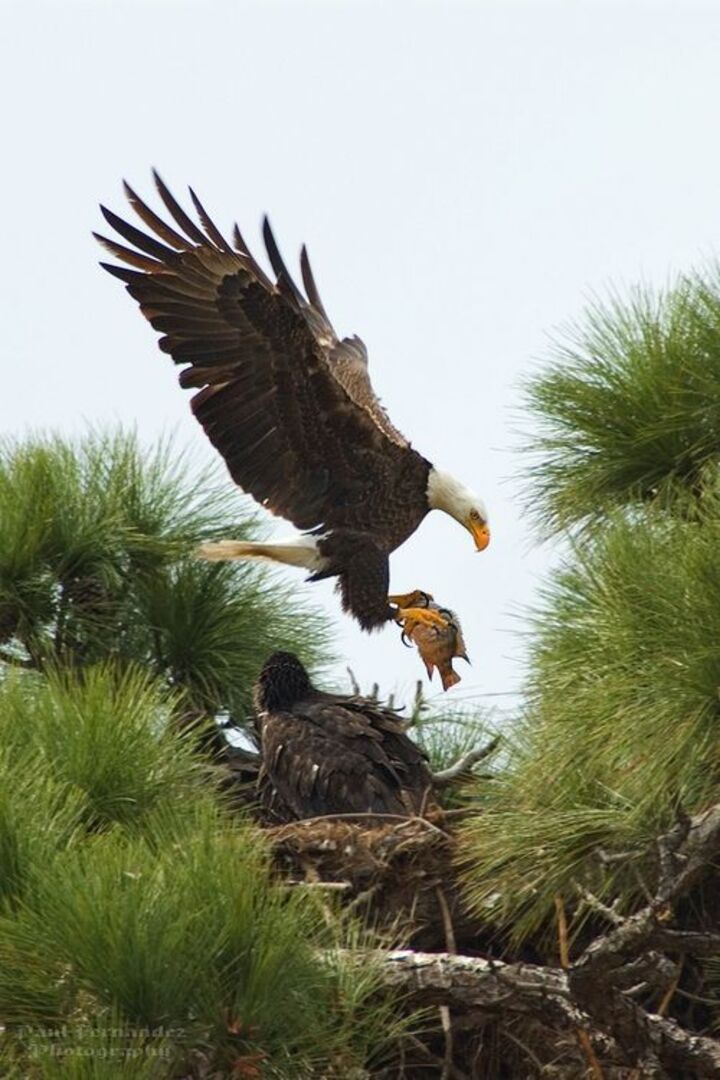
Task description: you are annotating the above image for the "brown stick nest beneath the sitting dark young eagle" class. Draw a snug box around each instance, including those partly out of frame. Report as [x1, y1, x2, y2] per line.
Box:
[223, 717, 500, 951]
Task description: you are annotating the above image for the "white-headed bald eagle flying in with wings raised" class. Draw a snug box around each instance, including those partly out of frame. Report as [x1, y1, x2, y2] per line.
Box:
[95, 173, 490, 630]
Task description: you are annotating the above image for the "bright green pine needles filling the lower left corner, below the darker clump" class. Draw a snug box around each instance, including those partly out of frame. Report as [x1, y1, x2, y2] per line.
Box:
[0, 667, 395, 1080]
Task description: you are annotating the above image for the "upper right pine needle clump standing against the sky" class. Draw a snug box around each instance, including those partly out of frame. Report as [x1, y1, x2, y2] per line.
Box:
[524, 270, 720, 532]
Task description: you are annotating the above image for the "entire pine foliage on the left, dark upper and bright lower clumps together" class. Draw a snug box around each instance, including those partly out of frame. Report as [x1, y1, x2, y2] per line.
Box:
[0, 433, 398, 1080]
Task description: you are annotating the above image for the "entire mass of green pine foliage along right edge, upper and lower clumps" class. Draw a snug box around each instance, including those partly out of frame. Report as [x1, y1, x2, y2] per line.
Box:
[462, 267, 720, 940]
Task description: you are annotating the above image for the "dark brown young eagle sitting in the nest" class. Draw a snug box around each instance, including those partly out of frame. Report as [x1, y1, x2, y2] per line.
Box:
[254, 652, 435, 821]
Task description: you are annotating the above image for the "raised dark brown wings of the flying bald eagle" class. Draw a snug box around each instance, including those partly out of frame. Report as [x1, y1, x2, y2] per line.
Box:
[96, 174, 418, 530]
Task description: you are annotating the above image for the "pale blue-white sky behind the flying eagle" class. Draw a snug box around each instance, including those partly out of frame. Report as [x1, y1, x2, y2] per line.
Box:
[0, 0, 720, 705]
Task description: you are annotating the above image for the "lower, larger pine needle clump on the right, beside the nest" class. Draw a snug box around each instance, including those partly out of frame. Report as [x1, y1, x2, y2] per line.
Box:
[465, 514, 720, 935]
